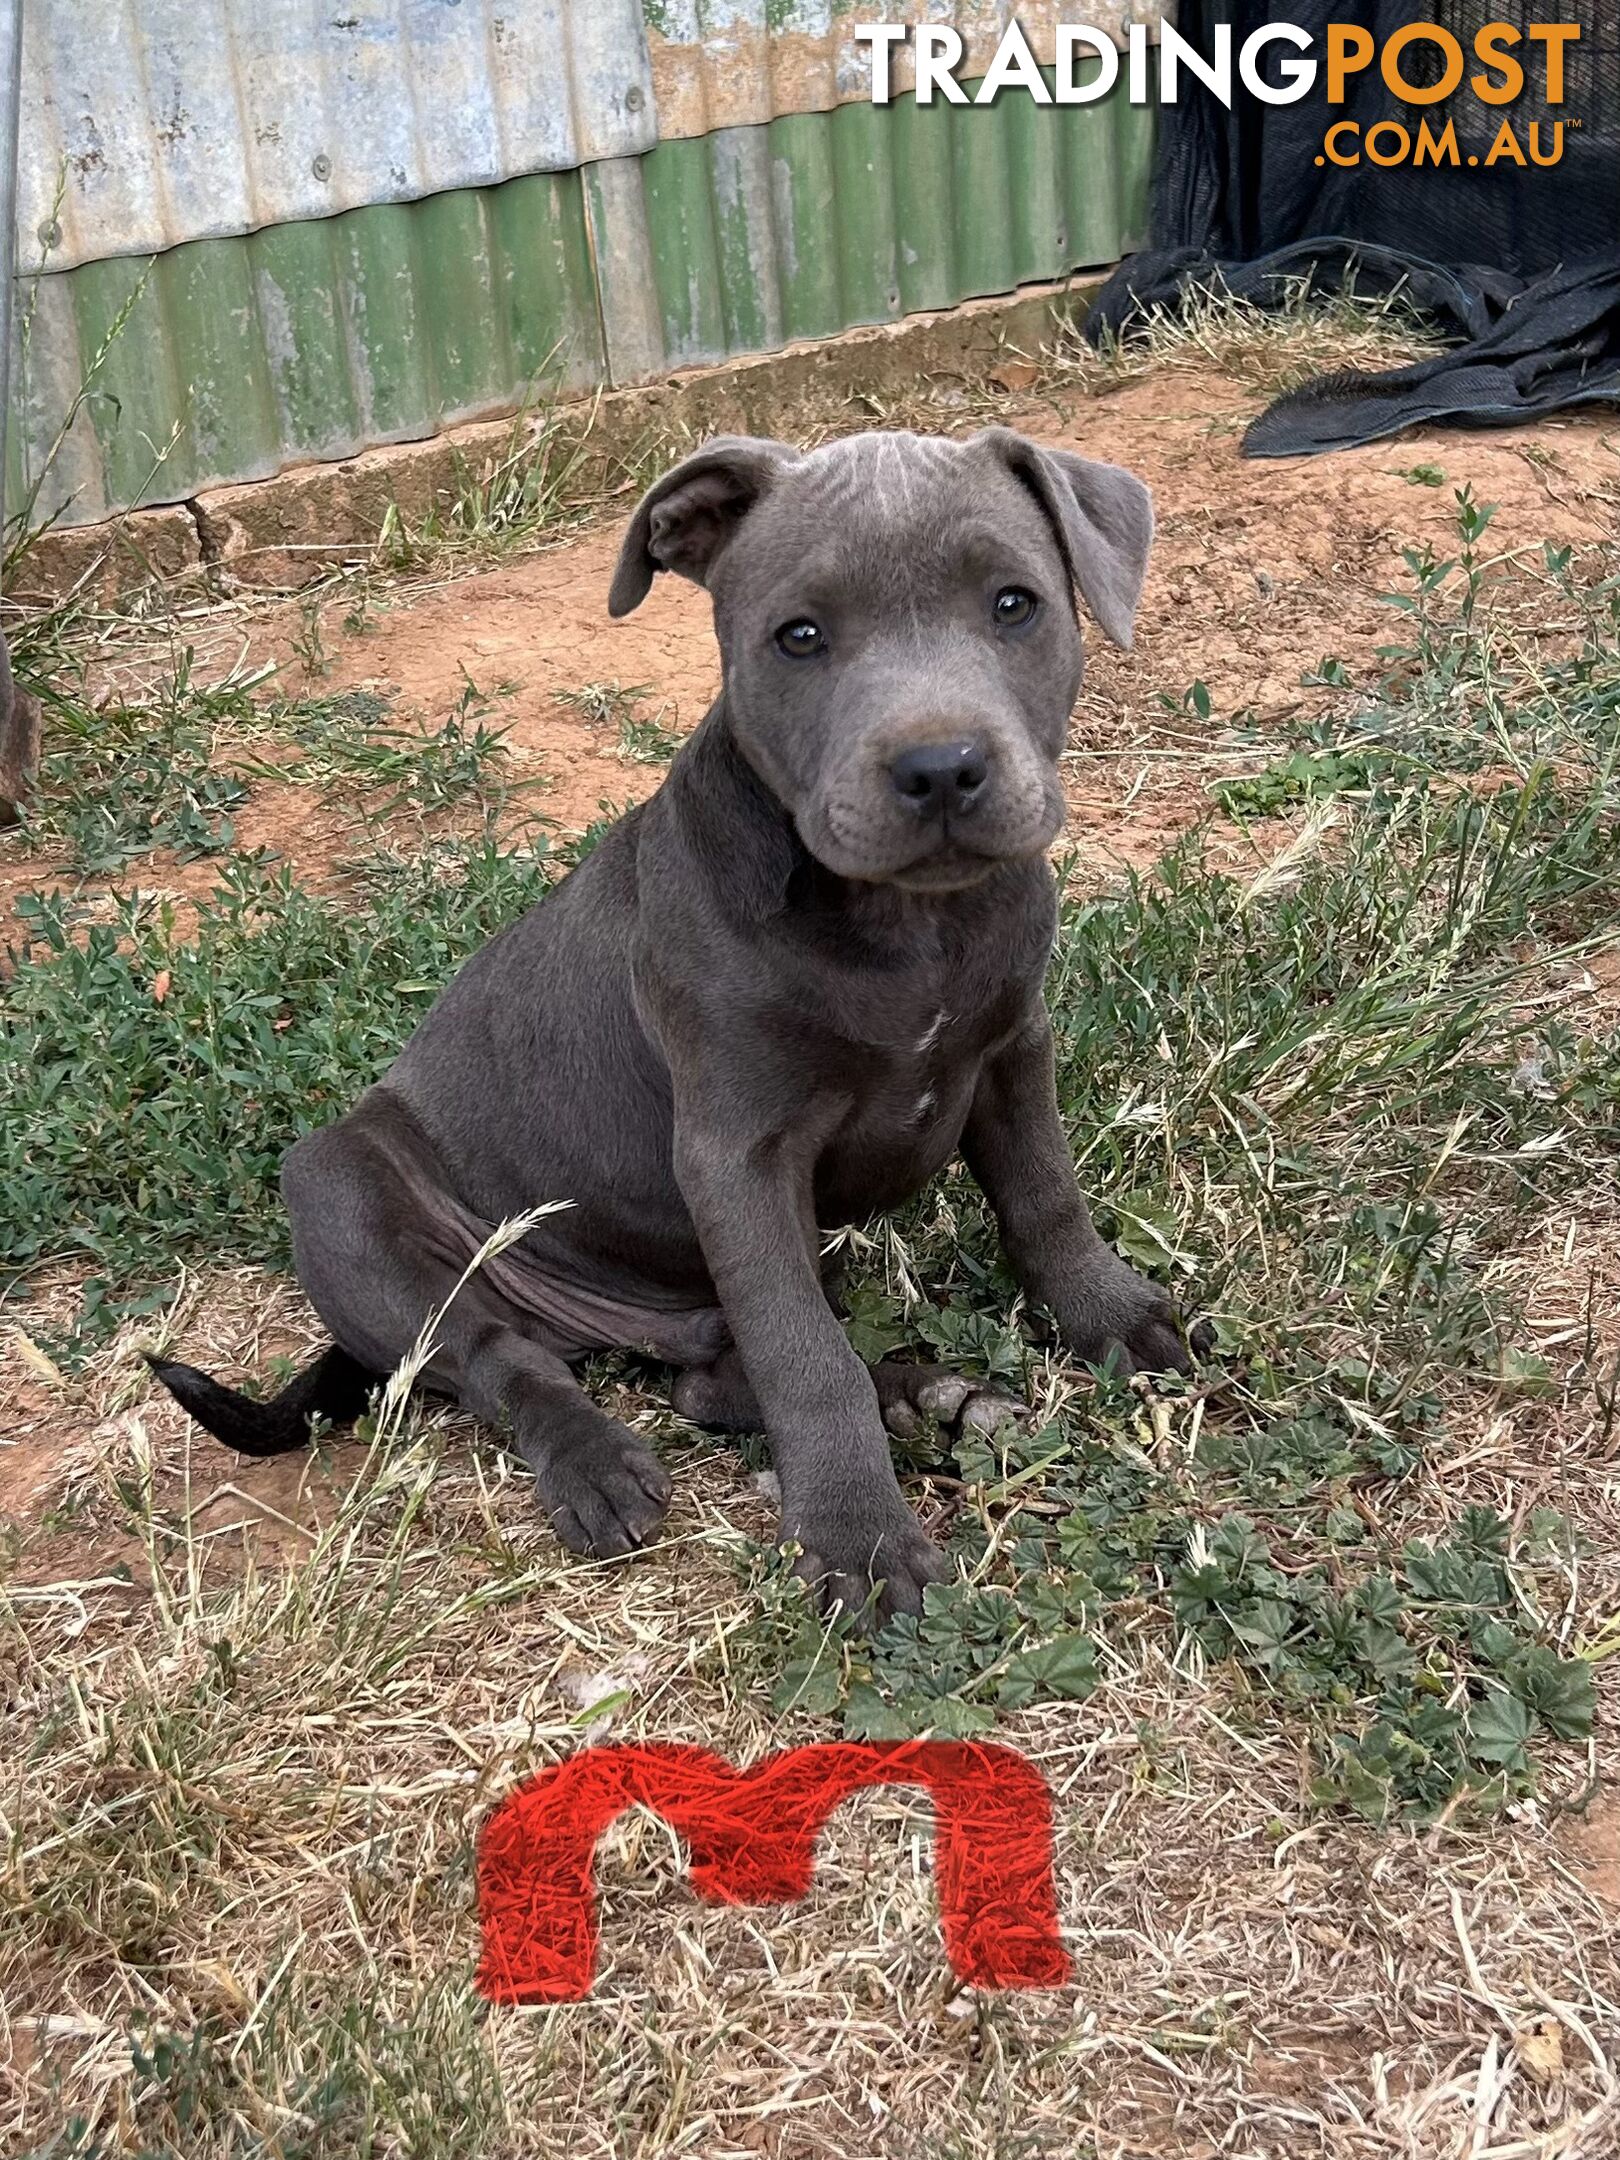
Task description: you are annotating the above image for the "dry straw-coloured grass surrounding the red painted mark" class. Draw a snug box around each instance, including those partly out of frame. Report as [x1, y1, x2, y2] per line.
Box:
[0, 1287, 1620, 2160]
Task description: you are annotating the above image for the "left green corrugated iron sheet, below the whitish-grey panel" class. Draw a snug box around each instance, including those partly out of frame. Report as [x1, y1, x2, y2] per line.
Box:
[6, 171, 605, 523]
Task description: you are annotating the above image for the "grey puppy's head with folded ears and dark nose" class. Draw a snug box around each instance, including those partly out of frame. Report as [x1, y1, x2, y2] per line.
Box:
[607, 428, 1153, 892]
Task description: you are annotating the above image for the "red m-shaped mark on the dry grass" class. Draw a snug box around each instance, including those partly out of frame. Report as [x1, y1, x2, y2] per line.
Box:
[477, 1741, 1069, 2002]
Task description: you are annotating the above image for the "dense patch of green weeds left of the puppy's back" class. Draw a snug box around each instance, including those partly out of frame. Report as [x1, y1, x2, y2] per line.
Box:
[0, 838, 553, 1311]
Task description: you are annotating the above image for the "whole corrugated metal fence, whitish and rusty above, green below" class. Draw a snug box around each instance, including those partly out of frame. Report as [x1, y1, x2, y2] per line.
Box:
[6, 0, 1158, 523]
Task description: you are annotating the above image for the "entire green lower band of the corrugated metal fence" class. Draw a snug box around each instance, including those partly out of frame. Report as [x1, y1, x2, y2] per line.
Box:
[6, 78, 1153, 523]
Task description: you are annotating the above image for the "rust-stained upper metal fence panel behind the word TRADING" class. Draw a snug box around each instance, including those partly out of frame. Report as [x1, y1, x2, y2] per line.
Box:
[642, 0, 1164, 143]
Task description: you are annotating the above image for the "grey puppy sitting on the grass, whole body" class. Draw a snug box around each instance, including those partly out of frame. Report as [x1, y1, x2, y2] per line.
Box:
[156, 428, 1201, 1614]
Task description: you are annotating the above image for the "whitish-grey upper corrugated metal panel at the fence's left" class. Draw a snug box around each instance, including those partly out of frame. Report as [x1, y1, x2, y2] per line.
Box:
[17, 0, 657, 270]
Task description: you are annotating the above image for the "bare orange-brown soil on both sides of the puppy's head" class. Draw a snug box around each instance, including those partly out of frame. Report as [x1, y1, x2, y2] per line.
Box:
[0, 354, 1620, 928]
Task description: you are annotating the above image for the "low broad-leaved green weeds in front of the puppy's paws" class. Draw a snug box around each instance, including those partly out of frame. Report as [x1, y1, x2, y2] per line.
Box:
[754, 1361, 1594, 1819]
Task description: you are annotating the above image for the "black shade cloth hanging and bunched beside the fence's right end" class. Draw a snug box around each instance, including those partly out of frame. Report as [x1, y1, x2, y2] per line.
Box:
[1086, 0, 1620, 458]
